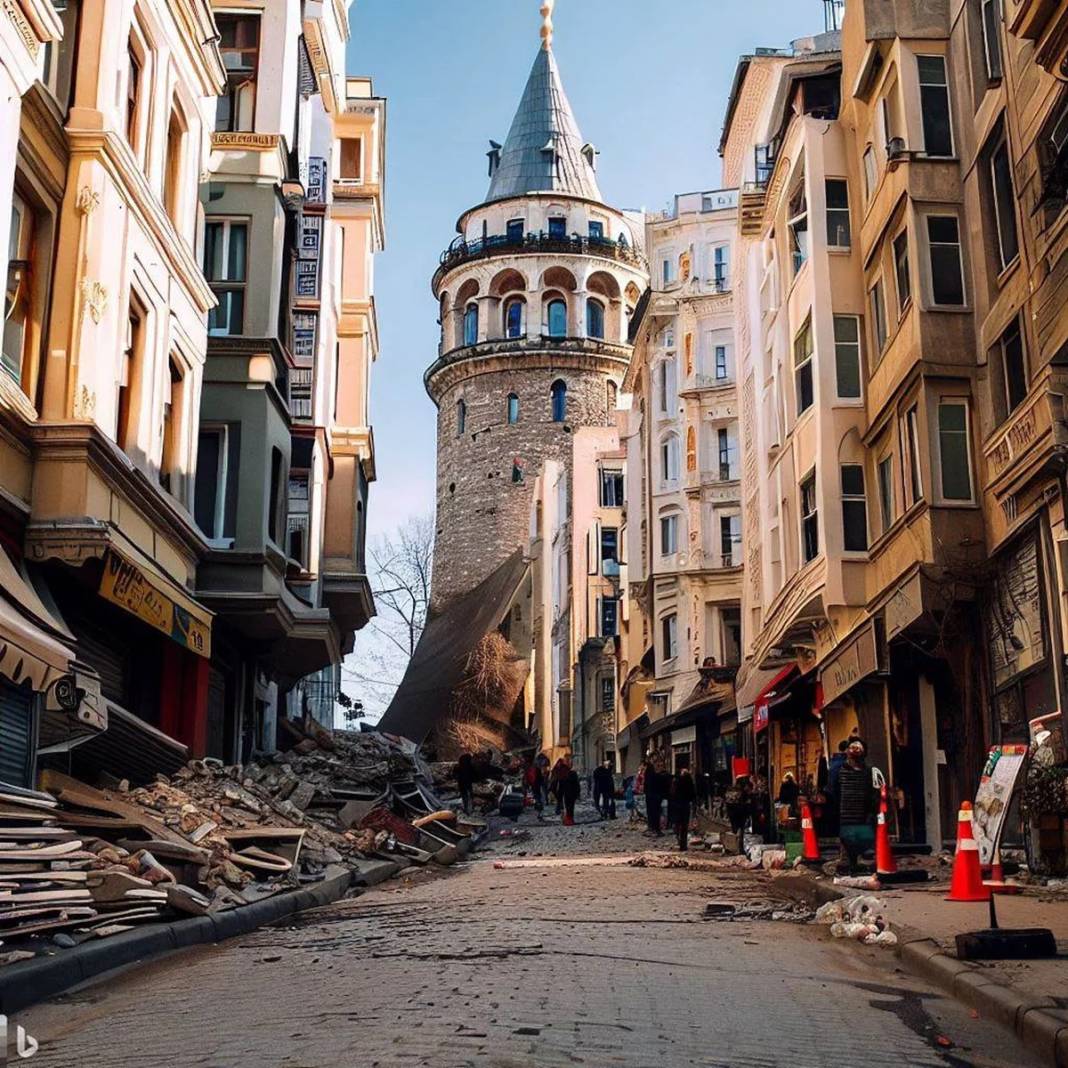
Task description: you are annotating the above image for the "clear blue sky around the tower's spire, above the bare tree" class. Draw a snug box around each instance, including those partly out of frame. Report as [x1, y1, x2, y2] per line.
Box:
[348, 0, 823, 535]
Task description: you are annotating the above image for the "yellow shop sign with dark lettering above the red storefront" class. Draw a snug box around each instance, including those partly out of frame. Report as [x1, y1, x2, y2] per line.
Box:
[99, 546, 213, 660]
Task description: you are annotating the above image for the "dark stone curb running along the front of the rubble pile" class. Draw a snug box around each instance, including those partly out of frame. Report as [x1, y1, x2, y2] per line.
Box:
[0, 865, 352, 1016]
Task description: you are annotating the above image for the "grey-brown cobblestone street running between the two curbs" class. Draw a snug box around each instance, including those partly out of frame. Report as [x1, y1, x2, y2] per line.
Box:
[18, 812, 1037, 1068]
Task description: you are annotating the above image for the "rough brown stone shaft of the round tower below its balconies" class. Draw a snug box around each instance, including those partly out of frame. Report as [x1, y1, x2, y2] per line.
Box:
[434, 368, 609, 606]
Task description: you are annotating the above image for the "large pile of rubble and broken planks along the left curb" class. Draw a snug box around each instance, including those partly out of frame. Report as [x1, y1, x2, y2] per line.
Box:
[0, 726, 482, 964]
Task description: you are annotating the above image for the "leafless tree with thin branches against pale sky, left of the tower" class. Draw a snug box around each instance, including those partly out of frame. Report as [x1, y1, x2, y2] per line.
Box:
[344, 515, 434, 709]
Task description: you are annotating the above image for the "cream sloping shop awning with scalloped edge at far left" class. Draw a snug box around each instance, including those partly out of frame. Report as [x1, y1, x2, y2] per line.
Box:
[0, 548, 75, 691]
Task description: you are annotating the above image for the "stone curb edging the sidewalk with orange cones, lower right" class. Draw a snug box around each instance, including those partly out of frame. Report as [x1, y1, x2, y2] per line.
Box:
[897, 927, 1068, 1068]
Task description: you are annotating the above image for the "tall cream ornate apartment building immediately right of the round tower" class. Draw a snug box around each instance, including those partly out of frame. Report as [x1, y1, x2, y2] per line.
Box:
[618, 189, 743, 772]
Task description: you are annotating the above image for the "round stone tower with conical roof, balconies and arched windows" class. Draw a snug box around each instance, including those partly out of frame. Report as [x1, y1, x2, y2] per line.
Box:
[424, 25, 647, 609]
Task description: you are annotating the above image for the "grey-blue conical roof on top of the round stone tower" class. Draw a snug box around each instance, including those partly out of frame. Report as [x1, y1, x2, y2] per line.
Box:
[486, 48, 601, 201]
